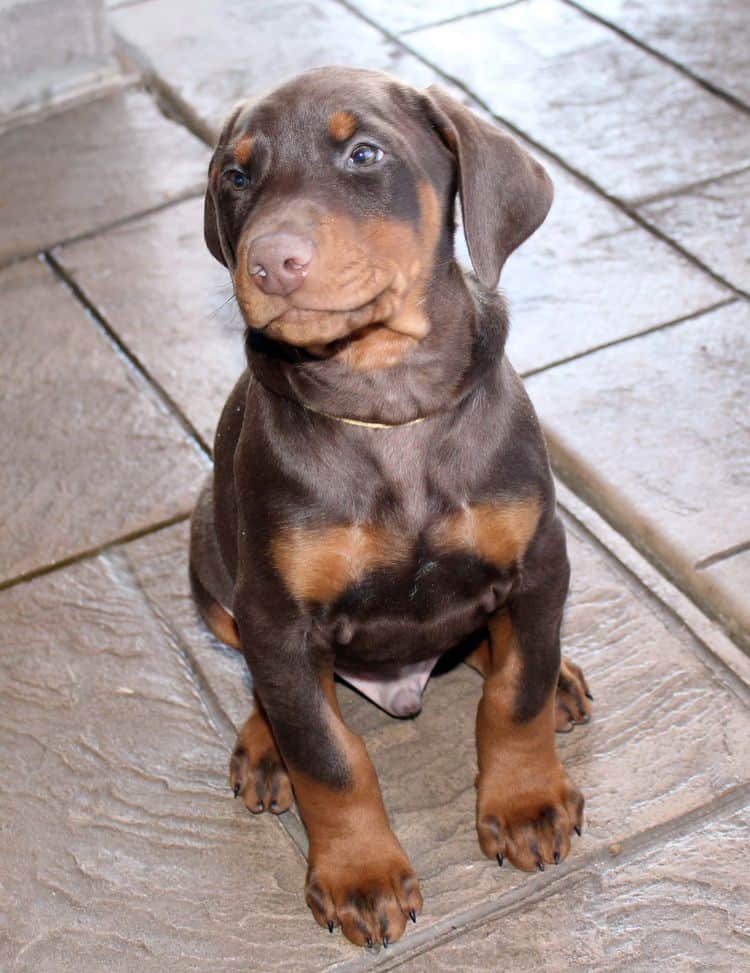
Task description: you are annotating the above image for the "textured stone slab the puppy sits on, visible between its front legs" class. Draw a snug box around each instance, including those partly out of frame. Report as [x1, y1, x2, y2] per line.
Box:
[124, 525, 750, 949]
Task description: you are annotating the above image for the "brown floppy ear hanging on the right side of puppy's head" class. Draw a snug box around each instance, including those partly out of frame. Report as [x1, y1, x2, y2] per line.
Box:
[427, 86, 554, 290]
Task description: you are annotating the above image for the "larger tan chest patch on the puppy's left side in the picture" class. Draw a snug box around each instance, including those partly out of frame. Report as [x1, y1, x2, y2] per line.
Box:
[271, 524, 409, 604]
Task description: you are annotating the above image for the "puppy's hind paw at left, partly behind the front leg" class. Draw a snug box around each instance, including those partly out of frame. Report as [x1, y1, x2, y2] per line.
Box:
[229, 711, 292, 814]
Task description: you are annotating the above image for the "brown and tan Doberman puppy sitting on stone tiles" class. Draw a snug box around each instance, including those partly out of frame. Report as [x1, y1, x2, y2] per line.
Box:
[190, 68, 589, 945]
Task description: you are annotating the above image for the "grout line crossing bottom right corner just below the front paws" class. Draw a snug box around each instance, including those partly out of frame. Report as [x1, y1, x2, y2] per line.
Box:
[364, 784, 750, 973]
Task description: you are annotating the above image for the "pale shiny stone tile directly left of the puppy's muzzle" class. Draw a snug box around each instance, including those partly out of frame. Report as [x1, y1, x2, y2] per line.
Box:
[56, 199, 245, 444]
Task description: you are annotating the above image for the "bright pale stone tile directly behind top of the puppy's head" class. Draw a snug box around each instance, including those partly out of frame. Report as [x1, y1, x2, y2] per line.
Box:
[111, 0, 440, 138]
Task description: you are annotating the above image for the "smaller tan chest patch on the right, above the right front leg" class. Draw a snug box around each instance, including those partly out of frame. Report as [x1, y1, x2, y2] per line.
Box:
[435, 498, 541, 568]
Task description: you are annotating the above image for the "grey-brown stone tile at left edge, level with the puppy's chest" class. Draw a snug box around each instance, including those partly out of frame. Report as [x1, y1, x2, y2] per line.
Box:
[0, 260, 207, 580]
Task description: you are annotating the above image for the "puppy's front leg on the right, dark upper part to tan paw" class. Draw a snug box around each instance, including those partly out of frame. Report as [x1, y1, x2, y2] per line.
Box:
[477, 521, 584, 871]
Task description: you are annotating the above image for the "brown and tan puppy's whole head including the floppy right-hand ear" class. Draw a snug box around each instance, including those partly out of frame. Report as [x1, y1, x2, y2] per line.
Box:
[205, 68, 552, 367]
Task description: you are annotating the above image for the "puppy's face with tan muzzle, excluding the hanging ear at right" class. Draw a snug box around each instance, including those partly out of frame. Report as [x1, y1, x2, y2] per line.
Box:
[207, 69, 453, 362]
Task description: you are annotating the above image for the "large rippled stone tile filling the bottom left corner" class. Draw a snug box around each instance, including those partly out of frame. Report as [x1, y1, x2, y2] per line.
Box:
[0, 558, 349, 973]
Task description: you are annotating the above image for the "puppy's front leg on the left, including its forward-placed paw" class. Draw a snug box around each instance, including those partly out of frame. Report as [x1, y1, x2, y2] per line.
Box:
[240, 620, 422, 946]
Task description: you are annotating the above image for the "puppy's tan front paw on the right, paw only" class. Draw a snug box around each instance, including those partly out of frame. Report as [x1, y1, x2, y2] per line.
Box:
[477, 764, 584, 872]
